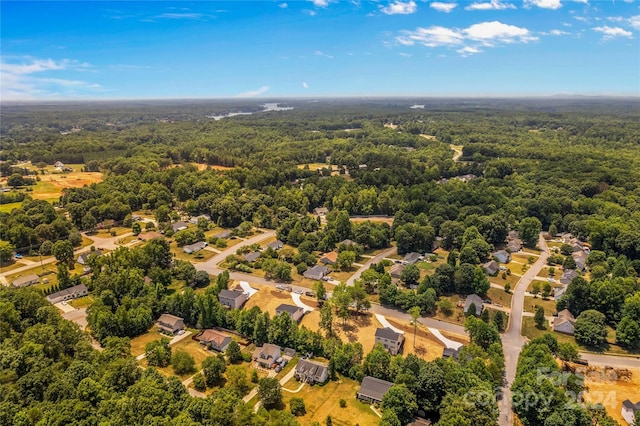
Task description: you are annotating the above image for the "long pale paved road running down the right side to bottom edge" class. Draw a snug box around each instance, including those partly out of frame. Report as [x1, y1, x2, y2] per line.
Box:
[498, 235, 549, 426]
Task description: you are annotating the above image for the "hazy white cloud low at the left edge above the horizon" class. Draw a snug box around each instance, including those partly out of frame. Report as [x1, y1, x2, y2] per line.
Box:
[0, 56, 102, 100]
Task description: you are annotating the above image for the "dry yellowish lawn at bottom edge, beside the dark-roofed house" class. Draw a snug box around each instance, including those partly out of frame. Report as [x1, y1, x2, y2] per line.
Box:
[282, 377, 380, 426]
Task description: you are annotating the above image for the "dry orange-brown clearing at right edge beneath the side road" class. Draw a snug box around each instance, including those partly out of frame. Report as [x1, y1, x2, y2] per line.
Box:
[583, 368, 640, 425]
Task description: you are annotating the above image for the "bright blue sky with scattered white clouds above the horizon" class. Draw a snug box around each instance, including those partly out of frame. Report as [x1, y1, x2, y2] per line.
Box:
[0, 0, 640, 100]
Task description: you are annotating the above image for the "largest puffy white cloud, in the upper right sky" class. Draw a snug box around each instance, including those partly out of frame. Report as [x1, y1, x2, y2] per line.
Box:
[396, 21, 538, 56]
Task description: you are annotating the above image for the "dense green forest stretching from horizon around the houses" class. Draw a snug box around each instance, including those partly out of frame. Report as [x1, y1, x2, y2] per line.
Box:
[0, 99, 640, 425]
